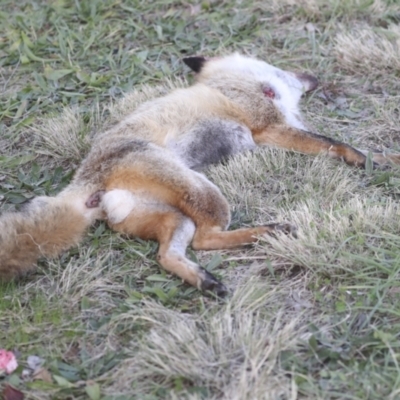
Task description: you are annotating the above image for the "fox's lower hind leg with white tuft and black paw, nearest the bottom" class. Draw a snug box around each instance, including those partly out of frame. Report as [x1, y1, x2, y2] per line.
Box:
[102, 189, 227, 296]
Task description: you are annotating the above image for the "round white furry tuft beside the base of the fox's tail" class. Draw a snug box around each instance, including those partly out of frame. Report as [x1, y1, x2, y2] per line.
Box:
[101, 189, 137, 224]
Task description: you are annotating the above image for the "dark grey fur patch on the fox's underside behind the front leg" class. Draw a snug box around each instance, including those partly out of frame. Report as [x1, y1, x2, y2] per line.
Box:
[167, 119, 256, 170]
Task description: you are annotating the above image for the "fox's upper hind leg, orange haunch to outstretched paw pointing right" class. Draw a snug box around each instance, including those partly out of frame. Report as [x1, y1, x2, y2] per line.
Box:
[104, 161, 295, 250]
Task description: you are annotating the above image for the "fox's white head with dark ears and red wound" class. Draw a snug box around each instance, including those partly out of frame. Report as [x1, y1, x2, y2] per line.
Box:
[183, 53, 318, 129]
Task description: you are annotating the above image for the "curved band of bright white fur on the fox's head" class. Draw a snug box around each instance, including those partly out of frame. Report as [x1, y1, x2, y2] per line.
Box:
[206, 53, 306, 129]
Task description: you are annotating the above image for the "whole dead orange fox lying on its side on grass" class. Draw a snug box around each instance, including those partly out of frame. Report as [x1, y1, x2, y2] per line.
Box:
[0, 54, 400, 294]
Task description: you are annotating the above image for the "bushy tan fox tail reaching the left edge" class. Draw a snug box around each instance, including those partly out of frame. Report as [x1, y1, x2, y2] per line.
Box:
[0, 194, 99, 280]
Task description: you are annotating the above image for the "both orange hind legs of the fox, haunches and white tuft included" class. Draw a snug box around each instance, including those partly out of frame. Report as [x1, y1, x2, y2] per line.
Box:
[102, 145, 293, 292]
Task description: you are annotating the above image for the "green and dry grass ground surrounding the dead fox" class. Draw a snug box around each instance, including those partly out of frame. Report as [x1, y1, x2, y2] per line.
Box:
[0, 0, 400, 400]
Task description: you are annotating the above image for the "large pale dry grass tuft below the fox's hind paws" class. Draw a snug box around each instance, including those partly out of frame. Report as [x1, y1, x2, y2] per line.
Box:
[105, 279, 306, 400]
